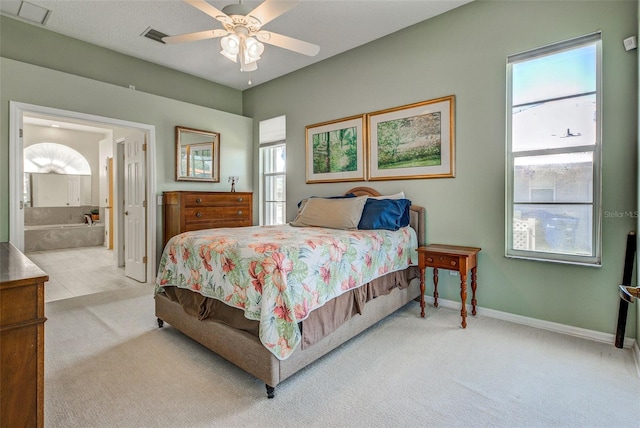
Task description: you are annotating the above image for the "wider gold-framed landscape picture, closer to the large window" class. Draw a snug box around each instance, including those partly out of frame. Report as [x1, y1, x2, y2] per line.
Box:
[367, 95, 455, 181]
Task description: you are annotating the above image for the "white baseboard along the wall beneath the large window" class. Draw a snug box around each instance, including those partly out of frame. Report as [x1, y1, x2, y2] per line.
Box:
[425, 296, 640, 352]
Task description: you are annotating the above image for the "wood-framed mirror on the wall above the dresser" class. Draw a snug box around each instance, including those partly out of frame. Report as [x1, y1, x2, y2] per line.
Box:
[176, 126, 220, 183]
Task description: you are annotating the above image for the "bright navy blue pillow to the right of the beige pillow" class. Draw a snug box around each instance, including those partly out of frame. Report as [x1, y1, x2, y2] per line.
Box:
[358, 198, 411, 230]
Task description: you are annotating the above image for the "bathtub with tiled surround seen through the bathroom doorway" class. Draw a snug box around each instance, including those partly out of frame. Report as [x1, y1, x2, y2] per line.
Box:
[24, 223, 104, 253]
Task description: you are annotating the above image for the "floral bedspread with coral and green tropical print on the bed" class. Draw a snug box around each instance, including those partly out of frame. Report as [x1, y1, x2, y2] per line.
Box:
[155, 225, 418, 360]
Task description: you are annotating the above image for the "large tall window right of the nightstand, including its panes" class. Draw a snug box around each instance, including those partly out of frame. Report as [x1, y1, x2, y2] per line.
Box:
[506, 32, 602, 266]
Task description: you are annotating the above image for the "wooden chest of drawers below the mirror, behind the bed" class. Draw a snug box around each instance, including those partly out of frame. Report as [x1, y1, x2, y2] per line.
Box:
[162, 191, 253, 245]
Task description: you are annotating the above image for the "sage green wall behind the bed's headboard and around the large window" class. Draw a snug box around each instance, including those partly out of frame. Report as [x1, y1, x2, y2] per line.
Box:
[243, 0, 638, 337]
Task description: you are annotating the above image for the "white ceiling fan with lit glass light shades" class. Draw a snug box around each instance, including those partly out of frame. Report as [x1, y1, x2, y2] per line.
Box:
[162, 0, 320, 71]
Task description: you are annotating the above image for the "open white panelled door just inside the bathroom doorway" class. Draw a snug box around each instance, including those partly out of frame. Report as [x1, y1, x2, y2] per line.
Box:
[124, 135, 147, 282]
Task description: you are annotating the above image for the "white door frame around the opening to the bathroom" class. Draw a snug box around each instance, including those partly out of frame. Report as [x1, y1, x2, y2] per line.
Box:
[9, 101, 156, 283]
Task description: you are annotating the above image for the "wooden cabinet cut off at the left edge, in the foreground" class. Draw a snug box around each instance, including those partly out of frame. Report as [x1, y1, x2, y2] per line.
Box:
[0, 242, 49, 427]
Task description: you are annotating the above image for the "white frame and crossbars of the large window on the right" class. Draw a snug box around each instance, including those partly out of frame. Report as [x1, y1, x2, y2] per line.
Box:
[505, 31, 602, 267]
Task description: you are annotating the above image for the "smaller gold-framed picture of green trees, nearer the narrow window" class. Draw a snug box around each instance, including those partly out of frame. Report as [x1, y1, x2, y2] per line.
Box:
[306, 115, 366, 183]
